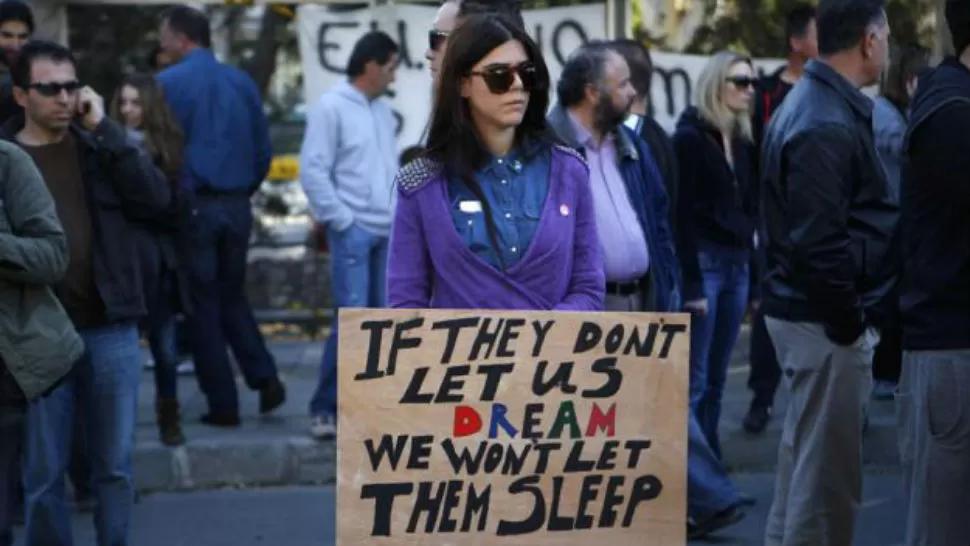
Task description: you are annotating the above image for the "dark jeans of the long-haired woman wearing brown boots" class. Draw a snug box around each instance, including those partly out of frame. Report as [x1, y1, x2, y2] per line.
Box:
[144, 271, 179, 399]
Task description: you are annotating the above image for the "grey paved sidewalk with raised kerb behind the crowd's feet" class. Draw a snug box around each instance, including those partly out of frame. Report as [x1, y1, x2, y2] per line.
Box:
[130, 331, 898, 491]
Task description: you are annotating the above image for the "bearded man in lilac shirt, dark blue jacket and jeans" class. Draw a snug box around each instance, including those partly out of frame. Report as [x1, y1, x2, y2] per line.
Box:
[549, 42, 744, 538]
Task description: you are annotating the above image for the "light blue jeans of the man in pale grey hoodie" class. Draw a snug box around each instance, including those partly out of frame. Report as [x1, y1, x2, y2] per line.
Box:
[310, 224, 387, 417]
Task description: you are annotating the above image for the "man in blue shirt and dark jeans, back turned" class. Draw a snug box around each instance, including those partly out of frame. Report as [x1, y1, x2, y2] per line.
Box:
[158, 6, 286, 427]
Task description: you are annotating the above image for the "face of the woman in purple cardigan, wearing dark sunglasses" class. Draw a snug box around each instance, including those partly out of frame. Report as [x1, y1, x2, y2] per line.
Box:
[461, 40, 535, 129]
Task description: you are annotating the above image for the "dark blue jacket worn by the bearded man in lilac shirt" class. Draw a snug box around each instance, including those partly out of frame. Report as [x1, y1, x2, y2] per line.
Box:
[548, 105, 681, 313]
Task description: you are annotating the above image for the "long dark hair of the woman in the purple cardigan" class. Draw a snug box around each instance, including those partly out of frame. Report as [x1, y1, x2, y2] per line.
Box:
[426, 14, 554, 268]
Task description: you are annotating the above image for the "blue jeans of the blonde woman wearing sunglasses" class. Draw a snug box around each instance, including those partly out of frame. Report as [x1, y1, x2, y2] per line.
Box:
[690, 245, 751, 458]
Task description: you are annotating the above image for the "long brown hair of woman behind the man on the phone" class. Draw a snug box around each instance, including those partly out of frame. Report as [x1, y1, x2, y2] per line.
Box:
[111, 74, 184, 179]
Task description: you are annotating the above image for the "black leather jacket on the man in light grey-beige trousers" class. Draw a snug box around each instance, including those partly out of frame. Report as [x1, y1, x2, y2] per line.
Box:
[761, 61, 900, 345]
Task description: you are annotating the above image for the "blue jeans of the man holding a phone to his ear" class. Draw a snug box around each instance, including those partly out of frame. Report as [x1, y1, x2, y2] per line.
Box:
[24, 323, 141, 546]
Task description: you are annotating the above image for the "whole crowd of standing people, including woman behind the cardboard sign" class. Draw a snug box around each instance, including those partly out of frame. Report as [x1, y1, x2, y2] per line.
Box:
[0, 0, 970, 546]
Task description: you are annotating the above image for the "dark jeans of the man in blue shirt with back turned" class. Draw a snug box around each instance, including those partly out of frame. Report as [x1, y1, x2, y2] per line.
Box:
[185, 194, 276, 415]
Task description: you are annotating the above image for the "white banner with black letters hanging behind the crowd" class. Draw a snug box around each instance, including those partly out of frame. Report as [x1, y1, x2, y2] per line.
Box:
[298, 4, 784, 149]
